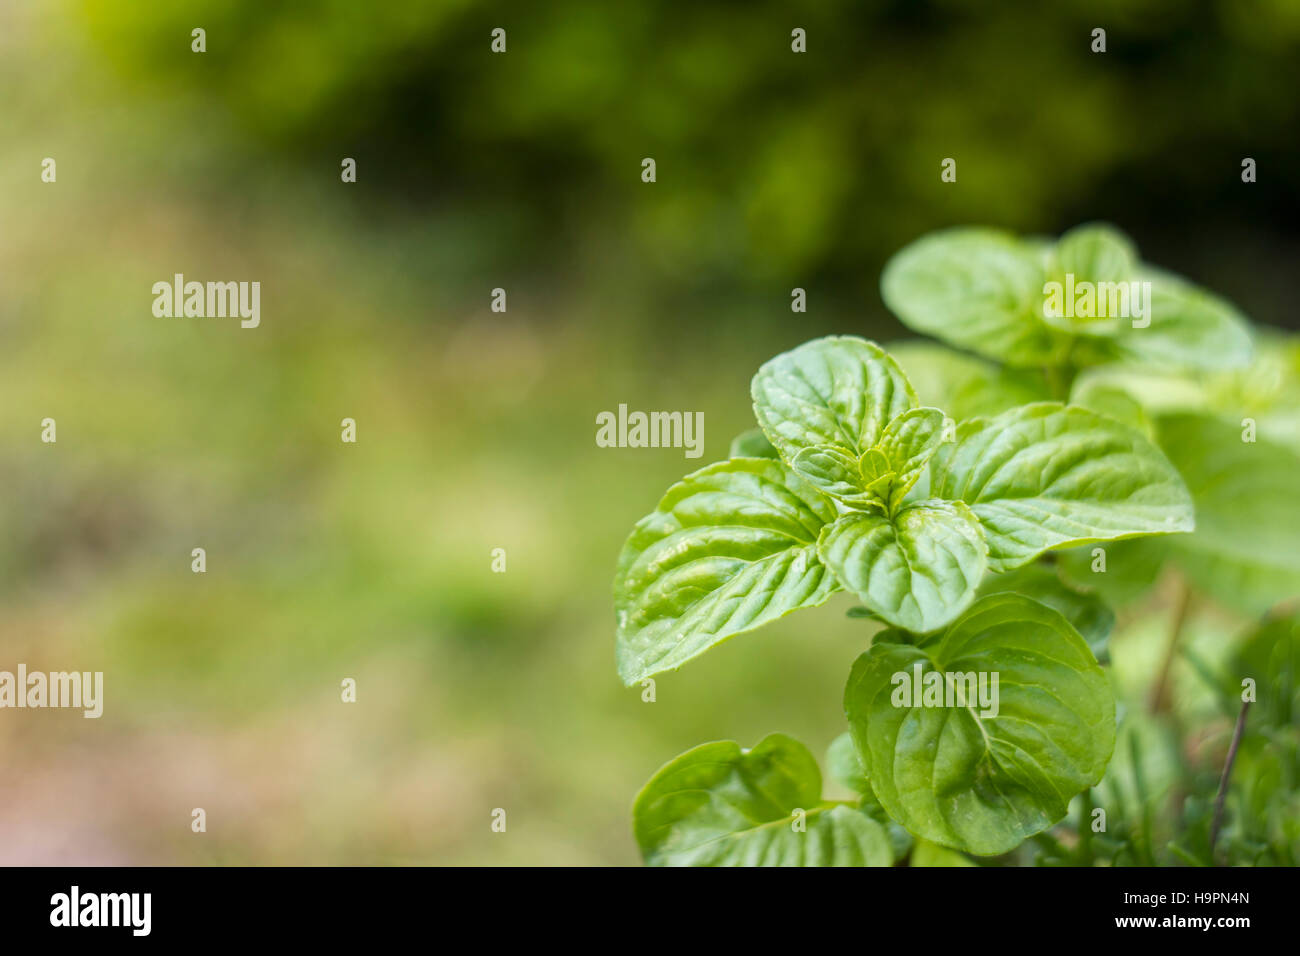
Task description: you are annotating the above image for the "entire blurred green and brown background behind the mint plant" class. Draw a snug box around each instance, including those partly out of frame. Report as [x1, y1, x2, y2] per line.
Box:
[0, 0, 1300, 865]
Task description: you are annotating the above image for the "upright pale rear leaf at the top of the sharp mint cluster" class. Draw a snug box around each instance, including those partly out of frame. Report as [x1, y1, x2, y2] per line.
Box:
[750, 336, 917, 462]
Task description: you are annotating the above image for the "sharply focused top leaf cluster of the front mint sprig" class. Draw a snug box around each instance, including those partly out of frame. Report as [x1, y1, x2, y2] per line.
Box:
[615, 338, 1192, 684]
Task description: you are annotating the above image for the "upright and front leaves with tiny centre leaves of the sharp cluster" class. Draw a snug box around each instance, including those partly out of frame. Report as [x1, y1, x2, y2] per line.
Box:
[751, 338, 987, 631]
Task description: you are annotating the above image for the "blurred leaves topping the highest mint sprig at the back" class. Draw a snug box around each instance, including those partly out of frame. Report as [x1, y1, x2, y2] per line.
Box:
[880, 225, 1251, 368]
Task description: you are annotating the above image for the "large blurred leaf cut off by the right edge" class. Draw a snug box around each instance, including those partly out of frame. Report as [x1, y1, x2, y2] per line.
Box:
[1157, 415, 1300, 614]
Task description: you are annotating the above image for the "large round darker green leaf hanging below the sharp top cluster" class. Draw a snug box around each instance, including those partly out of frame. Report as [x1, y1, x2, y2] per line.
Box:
[844, 594, 1115, 856]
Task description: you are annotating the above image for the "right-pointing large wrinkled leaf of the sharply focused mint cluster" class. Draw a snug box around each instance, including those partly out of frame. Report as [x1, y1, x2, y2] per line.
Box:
[931, 402, 1193, 571]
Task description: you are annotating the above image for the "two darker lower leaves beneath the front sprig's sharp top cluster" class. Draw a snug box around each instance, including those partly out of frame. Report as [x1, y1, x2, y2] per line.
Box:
[633, 593, 1115, 866]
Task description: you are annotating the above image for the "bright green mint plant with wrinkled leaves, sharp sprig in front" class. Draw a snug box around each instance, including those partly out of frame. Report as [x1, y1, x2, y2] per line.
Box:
[615, 226, 1300, 865]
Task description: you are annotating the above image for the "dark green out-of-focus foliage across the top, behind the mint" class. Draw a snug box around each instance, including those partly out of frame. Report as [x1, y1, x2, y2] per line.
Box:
[73, 0, 1300, 319]
